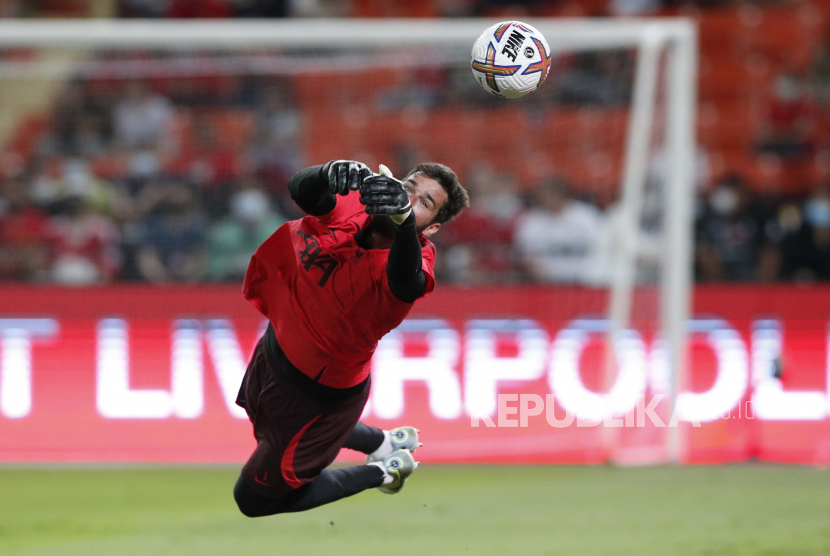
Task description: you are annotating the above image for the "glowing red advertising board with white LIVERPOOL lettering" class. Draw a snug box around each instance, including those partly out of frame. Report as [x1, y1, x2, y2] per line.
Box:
[0, 286, 830, 465]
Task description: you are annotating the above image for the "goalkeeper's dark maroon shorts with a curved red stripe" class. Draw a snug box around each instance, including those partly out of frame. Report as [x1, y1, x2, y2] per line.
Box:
[236, 330, 370, 496]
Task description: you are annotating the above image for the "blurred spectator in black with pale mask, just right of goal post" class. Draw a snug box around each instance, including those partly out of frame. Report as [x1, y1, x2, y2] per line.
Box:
[696, 175, 780, 281]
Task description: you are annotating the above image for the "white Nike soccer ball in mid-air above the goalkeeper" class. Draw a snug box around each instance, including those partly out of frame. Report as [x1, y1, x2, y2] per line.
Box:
[472, 21, 550, 98]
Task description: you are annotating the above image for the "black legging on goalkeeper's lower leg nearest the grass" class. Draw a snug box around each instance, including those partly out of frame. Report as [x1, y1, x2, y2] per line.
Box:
[233, 465, 383, 517]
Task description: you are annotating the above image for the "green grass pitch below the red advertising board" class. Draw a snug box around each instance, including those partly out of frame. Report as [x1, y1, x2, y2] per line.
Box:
[0, 465, 830, 556]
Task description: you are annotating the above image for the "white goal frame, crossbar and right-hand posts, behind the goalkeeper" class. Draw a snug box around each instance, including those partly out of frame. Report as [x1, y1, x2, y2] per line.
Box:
[0, 18, 698, 460]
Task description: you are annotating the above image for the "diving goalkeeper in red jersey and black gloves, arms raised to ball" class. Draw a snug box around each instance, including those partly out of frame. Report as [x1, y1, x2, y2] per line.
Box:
[234, 160, 469, 517]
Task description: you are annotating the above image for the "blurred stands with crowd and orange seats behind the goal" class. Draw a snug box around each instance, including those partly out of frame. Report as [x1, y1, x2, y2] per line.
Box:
[0, 0, 830, 285]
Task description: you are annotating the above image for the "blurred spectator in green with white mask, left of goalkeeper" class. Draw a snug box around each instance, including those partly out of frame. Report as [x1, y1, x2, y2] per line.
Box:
[207, 188, 286, 280]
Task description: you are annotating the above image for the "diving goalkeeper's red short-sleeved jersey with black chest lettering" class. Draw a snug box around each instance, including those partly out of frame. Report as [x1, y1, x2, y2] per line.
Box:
[242, 191, 435, 388]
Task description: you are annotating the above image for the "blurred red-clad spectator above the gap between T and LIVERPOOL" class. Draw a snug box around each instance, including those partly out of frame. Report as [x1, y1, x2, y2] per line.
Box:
[49, 194, 121, 286]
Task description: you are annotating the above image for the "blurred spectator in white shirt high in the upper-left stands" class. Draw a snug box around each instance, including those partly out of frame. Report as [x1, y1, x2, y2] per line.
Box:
[113, 81, 173, 149]
